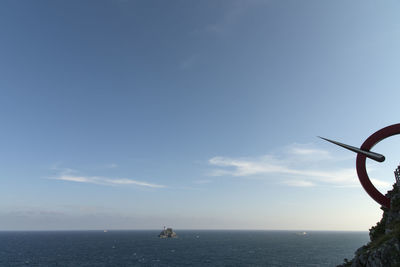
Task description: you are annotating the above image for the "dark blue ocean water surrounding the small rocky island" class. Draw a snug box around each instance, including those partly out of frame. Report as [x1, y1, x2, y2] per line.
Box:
[0, 230, 368, 267]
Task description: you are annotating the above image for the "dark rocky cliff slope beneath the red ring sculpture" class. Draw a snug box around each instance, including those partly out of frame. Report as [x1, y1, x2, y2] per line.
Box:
[339, 185, 400, 267]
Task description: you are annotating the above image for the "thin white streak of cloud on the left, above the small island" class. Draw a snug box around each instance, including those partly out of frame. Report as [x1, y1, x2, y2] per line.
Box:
[50, 174, 166, 188]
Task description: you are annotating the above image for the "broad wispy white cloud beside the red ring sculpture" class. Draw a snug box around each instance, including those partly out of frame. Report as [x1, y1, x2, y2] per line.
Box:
[209, 144, 390, 187]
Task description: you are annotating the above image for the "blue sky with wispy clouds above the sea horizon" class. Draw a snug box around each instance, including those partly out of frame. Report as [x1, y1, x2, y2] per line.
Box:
[0, 0, 400, 231]
